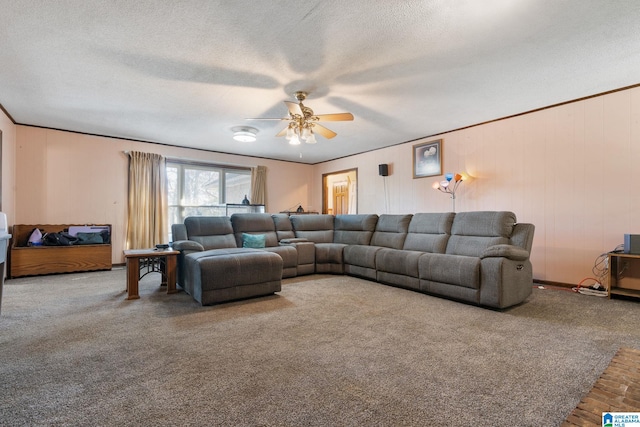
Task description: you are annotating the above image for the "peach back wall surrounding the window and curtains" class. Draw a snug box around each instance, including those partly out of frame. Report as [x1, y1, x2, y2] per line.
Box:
[10, 125, 312, 264]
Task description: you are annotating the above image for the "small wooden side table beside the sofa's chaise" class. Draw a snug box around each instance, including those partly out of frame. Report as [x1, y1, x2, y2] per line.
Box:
[124, 249, 180, 299]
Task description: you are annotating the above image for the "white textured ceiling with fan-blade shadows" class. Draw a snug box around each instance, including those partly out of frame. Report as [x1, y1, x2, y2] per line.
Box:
[0, 0, 640, 163]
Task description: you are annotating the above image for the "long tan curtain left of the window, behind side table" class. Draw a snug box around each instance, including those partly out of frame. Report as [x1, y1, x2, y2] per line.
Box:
[126, 151, 168, 249]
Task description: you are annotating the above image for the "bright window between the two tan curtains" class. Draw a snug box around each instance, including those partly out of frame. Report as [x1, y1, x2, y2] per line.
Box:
[167, 161, 251, 236]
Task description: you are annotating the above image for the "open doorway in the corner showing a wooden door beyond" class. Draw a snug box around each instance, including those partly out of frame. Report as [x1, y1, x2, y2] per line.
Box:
[322, 169, 358, 215]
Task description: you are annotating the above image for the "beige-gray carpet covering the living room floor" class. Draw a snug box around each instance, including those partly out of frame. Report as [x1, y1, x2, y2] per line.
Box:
[0, 270, 640, 426]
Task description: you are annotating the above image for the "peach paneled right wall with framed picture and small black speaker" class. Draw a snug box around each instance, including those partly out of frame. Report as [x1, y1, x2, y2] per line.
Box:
[311, 88, 640, 284]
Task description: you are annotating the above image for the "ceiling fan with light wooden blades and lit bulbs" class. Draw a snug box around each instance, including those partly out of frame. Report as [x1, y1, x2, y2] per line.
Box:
[247, 91, 353, 145]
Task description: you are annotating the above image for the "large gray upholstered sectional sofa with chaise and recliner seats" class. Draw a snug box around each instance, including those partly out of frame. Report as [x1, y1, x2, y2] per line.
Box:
[172, 211, 534, 309]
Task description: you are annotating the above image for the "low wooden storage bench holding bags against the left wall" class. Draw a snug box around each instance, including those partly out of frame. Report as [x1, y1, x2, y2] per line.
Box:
[8, 224, 112, 278]
